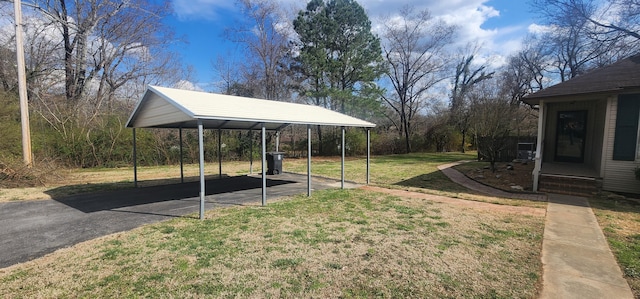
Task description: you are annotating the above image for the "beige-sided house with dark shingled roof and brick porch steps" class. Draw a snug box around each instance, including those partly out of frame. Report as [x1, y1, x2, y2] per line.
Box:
[523, 54, 640, 195]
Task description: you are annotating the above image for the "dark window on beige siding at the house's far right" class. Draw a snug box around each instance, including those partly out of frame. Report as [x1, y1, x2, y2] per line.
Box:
[613, 94, 640, 161]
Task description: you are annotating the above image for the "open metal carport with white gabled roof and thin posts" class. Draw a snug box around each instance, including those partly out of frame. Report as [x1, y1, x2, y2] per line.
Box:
[126, 86, 375, 219]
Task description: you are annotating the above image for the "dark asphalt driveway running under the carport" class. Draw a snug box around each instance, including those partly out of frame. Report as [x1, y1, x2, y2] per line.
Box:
[0, 174, 357, 268]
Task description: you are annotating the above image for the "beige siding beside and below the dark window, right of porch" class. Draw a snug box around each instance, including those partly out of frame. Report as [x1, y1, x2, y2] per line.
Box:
[602, 98, 640, 193]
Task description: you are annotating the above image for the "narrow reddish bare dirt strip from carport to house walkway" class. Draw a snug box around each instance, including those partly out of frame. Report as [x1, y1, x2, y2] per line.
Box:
[361, 186, 546, 217]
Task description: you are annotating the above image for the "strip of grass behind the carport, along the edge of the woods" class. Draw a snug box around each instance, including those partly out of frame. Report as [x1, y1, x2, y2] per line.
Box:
[0, 153, 475, 202]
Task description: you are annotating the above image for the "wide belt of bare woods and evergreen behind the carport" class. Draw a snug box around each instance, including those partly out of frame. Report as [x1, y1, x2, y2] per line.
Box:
[0, 0, 640, 167]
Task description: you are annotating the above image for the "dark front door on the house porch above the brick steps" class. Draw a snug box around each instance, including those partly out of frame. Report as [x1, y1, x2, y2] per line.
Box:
[555, 110, 587, 163]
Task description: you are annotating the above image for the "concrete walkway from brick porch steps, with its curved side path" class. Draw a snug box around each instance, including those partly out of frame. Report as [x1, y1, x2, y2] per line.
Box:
[438, 163, 634, 299]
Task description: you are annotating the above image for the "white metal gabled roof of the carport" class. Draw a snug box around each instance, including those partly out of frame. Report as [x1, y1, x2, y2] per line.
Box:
[127, 86, 376, 130]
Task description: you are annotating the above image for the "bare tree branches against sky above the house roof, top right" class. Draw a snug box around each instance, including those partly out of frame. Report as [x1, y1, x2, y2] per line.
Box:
[532, 0, 640, 81]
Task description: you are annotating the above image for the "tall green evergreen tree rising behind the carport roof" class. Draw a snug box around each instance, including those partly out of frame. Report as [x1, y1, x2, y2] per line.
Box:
[294, 0, 383, 117]
